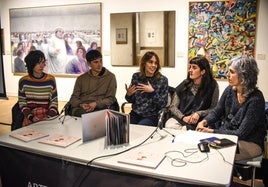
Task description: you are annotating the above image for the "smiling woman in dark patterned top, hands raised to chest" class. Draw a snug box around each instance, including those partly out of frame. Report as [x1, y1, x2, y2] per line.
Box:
[125, 51, 168, 126]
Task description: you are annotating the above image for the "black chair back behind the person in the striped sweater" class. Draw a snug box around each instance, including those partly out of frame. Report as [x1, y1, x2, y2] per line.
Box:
[11, 102, 24, 131]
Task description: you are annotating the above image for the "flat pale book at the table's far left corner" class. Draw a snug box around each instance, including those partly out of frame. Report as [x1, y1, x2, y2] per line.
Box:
[9, 128, 48, 142]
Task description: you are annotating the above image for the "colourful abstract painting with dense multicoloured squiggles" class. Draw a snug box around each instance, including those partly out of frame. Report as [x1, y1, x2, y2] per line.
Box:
[188, 0, 257, 79]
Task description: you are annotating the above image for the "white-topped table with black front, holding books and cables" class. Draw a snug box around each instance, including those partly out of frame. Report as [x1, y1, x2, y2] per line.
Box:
[0, 116, 237, 186]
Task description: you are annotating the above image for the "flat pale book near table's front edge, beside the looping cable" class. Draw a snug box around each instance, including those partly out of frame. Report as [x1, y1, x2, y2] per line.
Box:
[117, 149, 165, 169]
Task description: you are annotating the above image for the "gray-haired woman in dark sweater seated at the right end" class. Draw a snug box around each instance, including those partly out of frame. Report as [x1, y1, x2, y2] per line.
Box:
[196, 56, 266, 160]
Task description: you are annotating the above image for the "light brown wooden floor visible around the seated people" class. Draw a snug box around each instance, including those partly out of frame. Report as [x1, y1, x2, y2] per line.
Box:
[0, 97, 264, 187]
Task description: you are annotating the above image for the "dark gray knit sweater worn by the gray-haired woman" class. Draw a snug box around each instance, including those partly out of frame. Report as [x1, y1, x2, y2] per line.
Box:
[205, 86, 266, 148]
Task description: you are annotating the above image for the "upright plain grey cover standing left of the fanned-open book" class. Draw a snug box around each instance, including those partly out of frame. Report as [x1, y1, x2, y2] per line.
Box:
[81, 110, 107, 143]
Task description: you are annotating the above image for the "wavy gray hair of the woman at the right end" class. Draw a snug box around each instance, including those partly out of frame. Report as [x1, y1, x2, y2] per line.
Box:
[230, 56, 259, 98]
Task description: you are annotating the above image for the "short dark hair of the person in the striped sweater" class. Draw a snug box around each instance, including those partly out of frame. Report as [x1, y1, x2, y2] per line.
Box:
[24, 50, 45, 76]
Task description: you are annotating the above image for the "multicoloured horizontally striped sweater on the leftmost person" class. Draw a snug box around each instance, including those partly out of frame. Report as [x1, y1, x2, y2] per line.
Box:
[18, 73, 58, 119]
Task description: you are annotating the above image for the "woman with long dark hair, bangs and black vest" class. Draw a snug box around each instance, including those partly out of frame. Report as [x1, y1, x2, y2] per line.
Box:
[165, 56, 219, 130]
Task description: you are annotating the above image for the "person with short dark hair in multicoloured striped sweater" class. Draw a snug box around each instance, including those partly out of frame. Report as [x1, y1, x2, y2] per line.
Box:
[18, 50, 58, 126]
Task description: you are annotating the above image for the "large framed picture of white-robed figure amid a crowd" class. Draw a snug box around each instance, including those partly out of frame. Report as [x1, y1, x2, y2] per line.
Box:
[9, 3, 102, 76]
